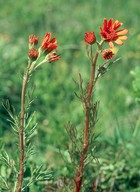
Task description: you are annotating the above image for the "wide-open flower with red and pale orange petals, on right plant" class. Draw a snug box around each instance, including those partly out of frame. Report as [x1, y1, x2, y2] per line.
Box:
[100, 18, 128, 48]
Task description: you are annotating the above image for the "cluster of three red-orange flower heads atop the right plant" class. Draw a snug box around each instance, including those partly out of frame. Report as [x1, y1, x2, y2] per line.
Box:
[84, 18, 128, 60]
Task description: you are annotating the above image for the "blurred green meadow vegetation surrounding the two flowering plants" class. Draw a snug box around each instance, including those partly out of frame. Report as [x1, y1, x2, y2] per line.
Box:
[0, 0, 140, 192]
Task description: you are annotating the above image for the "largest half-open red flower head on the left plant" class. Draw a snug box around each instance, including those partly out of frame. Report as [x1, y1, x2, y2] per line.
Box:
[41, 33, 58, 53]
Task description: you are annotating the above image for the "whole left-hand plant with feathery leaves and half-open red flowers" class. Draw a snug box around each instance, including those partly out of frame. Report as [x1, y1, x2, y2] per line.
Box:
[0, 33, 60, 192]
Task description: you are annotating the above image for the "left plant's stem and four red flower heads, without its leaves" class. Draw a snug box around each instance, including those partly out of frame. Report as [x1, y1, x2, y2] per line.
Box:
[16, 33, 60, 192]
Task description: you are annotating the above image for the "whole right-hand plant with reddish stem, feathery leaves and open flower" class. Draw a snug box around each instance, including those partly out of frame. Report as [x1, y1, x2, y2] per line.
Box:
[66, 18, 128, 192]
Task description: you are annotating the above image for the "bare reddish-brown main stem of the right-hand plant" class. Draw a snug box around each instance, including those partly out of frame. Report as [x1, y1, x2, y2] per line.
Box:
[74, 47, 99, 192]
